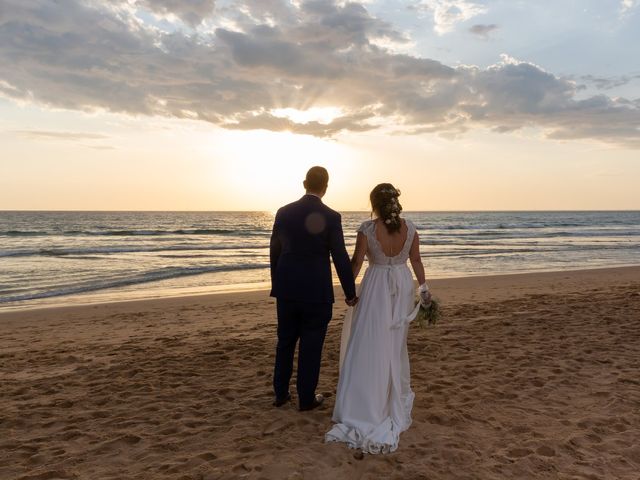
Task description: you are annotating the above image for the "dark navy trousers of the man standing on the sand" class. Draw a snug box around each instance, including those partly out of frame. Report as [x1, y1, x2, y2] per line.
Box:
[273, 299, 333, 407]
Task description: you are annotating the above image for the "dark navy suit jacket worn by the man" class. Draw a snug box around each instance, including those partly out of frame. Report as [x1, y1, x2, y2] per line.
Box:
[270, 195, 356, 303]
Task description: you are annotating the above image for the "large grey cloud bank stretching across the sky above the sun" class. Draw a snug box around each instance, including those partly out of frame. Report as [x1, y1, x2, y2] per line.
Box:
[0, 0, 640, 148]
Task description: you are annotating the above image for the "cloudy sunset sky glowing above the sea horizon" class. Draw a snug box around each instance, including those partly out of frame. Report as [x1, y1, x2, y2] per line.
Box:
[0, 0, 640, 211]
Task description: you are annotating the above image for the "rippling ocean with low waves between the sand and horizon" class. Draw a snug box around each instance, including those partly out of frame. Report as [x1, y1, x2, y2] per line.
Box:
[0, 211, 640, 310]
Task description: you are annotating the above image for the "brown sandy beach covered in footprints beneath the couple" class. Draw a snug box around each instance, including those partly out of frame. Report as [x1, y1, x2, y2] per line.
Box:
[0, 267, 640, 480]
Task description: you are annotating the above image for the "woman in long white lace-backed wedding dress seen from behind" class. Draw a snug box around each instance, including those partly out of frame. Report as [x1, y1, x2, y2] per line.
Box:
[325, 183, 431, 453]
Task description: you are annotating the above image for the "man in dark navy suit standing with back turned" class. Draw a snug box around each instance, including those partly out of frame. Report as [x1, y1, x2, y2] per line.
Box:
[270, 167, 358, 411]
